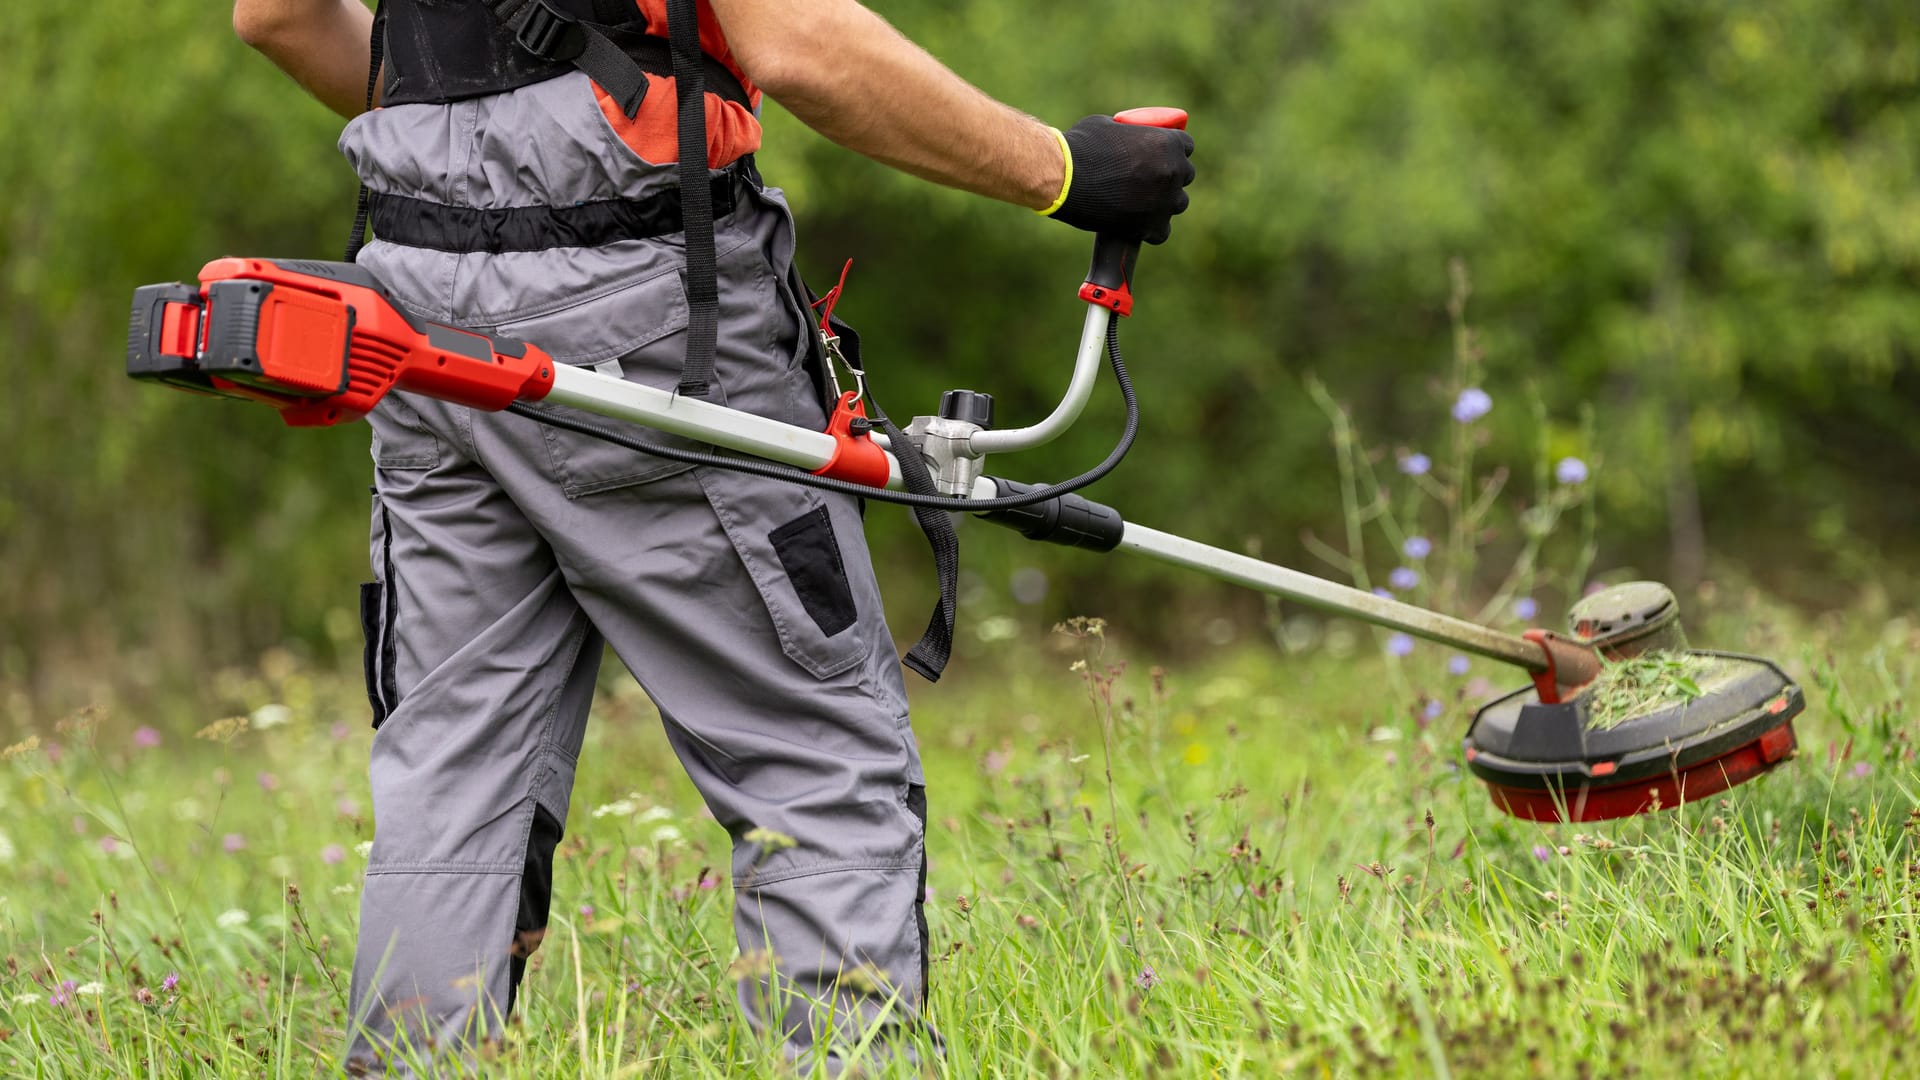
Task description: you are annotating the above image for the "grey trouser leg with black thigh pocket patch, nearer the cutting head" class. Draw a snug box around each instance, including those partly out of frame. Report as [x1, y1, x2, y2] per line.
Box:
[490, 424, 927, 1053]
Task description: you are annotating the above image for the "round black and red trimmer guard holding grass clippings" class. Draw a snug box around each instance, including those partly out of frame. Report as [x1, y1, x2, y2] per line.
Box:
[1465, 651, 1805, 821]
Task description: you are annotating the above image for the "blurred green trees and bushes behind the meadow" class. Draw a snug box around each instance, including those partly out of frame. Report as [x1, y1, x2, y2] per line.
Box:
[0, 0, 1920, 707]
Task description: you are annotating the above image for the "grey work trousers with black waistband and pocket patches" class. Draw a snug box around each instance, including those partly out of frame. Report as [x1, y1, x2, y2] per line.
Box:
[342, 75, 925, 1061]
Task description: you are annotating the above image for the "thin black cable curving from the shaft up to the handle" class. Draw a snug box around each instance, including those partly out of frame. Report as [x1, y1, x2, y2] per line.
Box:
[507, 321, 1140, 513]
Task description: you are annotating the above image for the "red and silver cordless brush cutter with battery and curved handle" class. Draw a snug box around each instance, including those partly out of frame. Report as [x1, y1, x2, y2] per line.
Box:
[127, 110, 1805, 821]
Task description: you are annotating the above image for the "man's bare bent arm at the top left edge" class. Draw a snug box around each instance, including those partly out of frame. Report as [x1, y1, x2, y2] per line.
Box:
[234, 0, 372, 117]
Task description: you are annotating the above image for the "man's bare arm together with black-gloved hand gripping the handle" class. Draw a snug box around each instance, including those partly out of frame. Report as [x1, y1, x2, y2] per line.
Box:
[712, 0, 1192, 242]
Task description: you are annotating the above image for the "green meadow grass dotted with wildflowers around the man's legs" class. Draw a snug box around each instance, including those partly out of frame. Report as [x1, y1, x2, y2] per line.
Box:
[0, 599, 1920, 1078]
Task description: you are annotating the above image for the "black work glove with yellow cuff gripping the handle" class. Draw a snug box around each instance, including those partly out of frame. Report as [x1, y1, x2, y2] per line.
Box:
[1048, 115, 1194, 244]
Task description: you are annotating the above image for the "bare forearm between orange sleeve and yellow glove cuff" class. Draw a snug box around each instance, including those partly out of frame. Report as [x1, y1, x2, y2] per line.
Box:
[712, 0, 1066, 209]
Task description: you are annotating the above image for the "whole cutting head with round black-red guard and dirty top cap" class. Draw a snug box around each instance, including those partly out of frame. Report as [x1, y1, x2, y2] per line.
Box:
[1465, 582, 1805, 821]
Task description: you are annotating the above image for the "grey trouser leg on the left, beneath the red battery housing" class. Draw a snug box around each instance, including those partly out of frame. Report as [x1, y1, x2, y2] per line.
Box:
[349, 398, 601, 1072]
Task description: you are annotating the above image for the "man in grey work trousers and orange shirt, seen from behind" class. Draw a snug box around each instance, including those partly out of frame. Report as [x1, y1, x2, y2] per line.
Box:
[234, 0, 1192, 1063]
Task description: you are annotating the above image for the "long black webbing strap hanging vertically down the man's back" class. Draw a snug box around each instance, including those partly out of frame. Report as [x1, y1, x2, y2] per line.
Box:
[666, 0, 720, 398]
